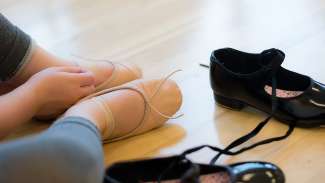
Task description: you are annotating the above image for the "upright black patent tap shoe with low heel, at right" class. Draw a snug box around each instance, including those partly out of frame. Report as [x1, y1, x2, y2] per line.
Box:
[210, 48, 325, 127]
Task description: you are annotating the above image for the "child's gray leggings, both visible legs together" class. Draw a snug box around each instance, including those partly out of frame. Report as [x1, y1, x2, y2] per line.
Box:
[0, 13, 104, 183]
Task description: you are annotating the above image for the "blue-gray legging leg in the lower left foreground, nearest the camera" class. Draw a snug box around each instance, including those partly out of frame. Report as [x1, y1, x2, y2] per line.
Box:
[0, 117, 104, 183]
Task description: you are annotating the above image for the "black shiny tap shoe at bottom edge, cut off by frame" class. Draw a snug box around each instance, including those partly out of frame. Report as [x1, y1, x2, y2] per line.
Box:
[105, 146, 285, 183]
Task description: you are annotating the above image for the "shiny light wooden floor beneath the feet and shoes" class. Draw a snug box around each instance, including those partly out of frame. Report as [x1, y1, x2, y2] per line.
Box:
[0, 0, 325, 183]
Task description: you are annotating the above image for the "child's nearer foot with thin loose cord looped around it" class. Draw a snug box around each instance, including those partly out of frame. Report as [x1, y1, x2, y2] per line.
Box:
[63, 80, 182, 142]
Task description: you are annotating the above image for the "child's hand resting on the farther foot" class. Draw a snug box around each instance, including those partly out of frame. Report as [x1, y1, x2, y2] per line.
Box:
[26, 67, 95, 116]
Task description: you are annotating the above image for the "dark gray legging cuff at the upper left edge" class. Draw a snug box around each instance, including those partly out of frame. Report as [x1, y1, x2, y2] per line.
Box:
[0, 13, 32, 81]
